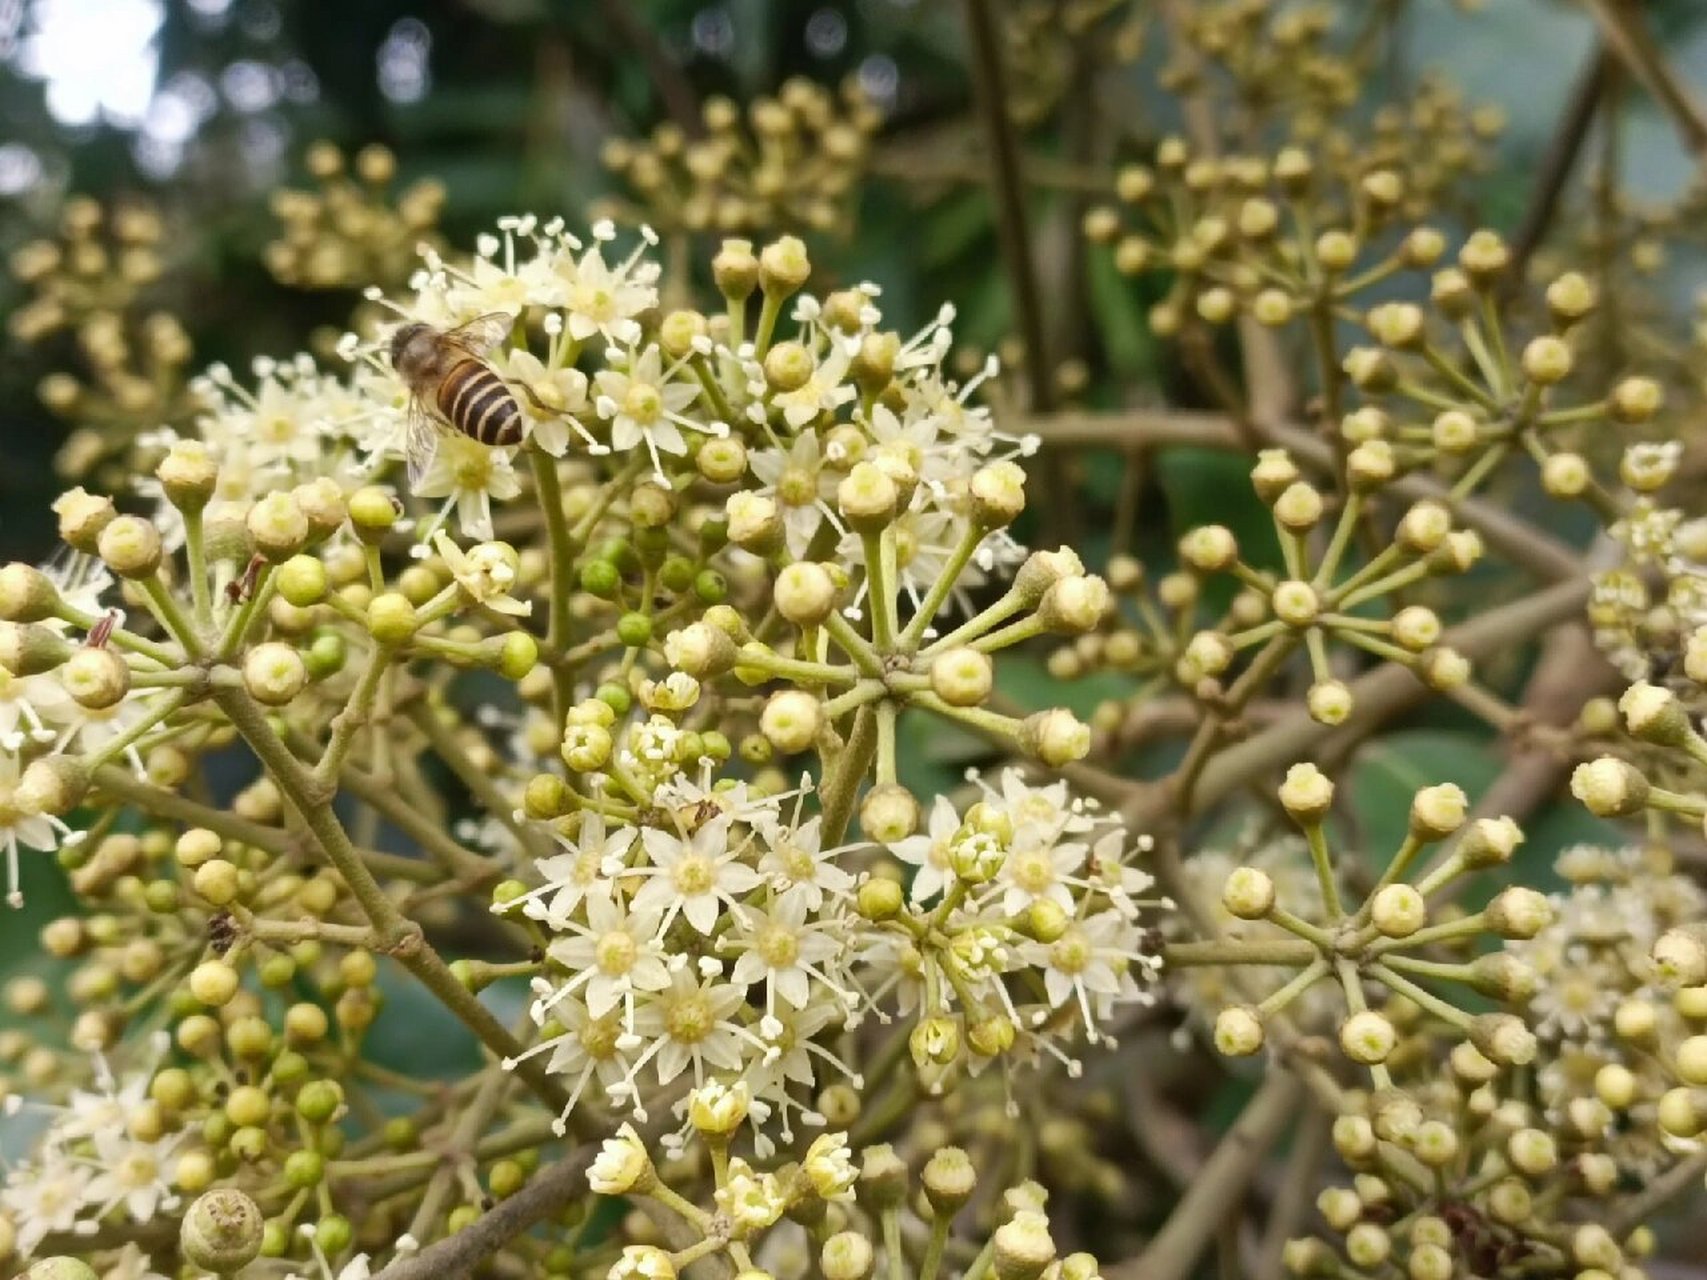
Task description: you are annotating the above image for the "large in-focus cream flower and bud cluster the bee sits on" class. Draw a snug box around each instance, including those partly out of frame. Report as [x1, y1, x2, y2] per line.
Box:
[0, 218, 1164, 1275]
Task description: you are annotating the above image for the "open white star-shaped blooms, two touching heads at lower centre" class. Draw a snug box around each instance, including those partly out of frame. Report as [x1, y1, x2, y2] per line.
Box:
[495, 761, 1159, 1138]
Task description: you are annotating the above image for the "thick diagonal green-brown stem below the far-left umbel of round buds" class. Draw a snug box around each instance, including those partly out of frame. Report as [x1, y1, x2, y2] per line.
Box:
[213, 689, 568, 1111]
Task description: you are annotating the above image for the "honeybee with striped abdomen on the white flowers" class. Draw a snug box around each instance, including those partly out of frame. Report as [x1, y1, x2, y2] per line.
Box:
[391, 311, 522, 485]
